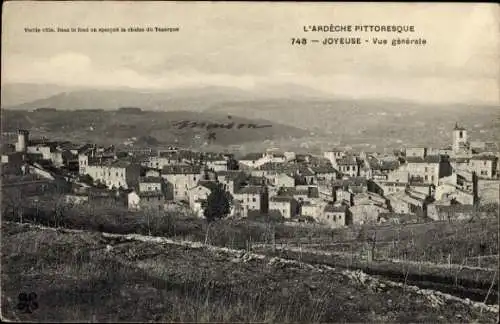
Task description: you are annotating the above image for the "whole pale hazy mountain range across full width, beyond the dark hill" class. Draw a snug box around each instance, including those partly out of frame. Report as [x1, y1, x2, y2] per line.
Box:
[2, 84, 500, 147]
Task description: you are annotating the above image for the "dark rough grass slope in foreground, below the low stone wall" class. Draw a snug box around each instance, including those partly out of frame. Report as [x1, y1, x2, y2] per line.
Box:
[2, 223, 497, 322]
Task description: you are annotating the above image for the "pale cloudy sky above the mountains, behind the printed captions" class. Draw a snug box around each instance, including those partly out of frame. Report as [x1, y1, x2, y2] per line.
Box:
[2, 1, 500, 105]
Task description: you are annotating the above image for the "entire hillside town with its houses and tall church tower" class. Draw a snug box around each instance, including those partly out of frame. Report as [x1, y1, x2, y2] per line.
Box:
[1, 123, 500, 228]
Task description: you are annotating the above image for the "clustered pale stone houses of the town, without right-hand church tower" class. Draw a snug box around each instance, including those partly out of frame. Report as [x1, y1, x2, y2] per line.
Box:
[2, 124, 498, 227]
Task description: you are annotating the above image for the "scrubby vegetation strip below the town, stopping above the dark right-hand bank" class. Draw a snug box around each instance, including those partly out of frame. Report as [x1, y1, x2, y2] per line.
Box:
[2, 195, 498, 267]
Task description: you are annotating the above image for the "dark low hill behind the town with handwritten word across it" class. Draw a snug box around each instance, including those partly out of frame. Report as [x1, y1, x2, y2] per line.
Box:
[2, 110, 307, 147]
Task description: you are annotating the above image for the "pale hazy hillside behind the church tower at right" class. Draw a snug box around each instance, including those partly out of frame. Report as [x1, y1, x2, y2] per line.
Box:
[207, 99, 500, 148]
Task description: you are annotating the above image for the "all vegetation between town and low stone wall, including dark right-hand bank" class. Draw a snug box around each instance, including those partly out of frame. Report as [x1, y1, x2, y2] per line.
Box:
[3, 195, 498, 304]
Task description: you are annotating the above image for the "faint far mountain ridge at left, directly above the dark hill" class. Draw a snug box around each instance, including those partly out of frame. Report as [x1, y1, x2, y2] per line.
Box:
[2, 84, 329, 111]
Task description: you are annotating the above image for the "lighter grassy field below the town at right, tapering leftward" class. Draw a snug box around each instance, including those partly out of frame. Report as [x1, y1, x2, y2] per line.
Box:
[277, 215, 499, 268]
